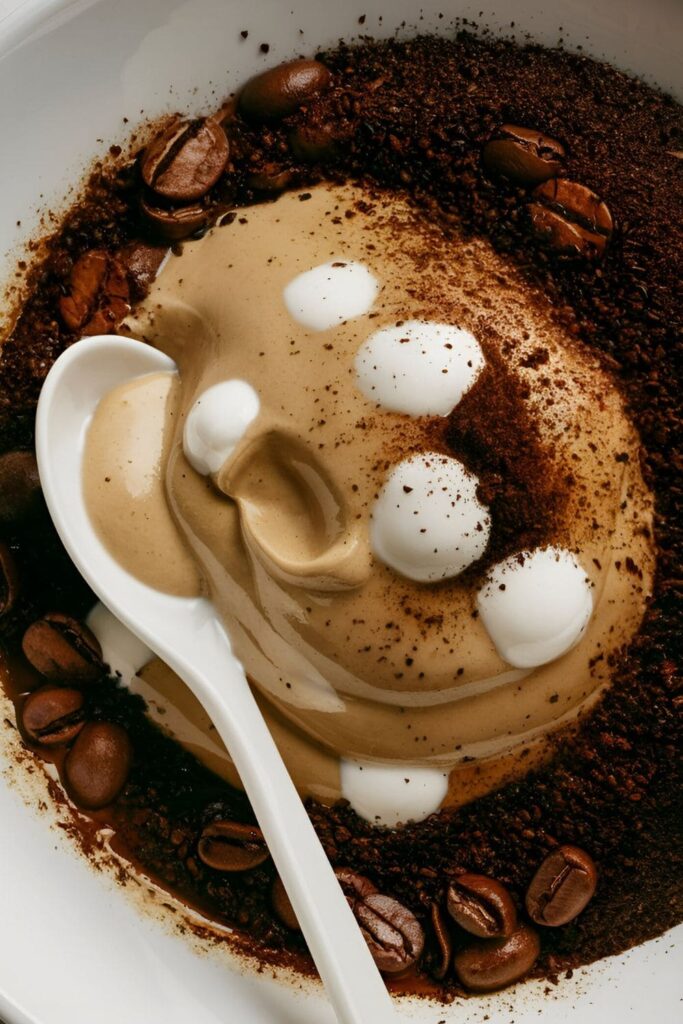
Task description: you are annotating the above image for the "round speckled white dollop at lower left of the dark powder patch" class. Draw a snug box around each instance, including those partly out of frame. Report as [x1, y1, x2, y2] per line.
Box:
[370, 452, 490, 583]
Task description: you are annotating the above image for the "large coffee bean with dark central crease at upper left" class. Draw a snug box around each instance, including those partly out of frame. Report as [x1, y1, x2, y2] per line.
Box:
[140, 118, 228, 203]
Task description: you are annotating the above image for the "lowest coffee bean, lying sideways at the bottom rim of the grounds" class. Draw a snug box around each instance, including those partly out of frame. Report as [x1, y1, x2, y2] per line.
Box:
[453, 925, 541, 992]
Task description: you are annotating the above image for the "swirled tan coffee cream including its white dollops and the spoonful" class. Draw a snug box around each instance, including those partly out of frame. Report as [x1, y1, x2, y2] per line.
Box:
[85, 185, 653, 823]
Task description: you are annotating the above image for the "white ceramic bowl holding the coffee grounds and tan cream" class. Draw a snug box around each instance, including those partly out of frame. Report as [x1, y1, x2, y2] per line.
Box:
[0, 0, 683, 1024]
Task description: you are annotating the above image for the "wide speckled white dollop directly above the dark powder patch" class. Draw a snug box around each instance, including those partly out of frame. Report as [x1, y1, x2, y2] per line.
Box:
[354, 321, 485, 416]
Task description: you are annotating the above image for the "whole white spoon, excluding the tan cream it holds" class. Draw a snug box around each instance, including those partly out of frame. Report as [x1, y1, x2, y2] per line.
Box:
[36, 336, 395, 1024]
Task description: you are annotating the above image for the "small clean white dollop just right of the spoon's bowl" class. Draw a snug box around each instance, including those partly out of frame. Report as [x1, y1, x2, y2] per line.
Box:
[182, 380, 260, 476]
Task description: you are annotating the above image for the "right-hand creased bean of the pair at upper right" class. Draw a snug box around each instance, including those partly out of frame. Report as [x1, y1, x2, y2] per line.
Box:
[528, 178, 613, 259]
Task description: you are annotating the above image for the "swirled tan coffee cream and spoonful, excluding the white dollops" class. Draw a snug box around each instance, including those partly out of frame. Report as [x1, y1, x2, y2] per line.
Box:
[85, 186, 652, 818]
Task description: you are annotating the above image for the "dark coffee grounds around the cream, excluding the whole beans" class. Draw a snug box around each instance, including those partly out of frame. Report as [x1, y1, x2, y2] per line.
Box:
[0, 28, 683, 998]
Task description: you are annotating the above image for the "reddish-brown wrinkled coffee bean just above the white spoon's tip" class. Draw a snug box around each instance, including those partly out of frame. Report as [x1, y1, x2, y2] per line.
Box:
[59, 249, 130, 335]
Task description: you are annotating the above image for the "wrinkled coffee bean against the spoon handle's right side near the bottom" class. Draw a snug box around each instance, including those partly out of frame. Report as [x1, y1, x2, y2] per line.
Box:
[335, 867, 425, 974]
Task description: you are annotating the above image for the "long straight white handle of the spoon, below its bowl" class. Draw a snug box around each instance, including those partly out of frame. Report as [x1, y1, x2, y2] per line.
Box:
[165, 623, 395, 1024]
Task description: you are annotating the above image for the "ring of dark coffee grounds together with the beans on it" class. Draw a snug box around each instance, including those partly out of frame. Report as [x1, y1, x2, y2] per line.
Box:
[0, 28, 683, 999]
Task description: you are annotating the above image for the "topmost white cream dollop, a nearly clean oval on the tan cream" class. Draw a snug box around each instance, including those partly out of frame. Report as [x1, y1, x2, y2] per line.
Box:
[283, 259, 379, 331]
